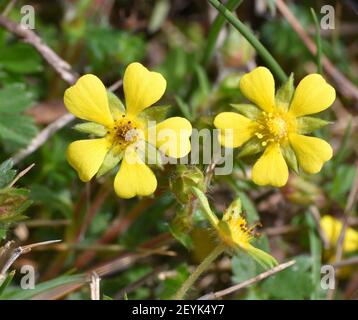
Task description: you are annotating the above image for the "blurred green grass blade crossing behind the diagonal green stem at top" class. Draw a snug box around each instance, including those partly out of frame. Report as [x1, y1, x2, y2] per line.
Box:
[203, 0, 242, 66]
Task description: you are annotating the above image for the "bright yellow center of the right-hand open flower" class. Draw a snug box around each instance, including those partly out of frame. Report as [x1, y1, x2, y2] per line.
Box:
[255, 112, 295, 147]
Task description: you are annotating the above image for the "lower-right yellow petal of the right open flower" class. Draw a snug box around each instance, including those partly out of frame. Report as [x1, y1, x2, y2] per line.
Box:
[289, 133, 333, 173]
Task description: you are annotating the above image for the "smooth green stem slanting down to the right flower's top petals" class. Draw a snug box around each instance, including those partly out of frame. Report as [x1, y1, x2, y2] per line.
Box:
[208, 0, 287, 82]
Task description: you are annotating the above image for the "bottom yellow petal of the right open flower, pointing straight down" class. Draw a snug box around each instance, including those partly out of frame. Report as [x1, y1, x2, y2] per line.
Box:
[252, 143, 288, 187]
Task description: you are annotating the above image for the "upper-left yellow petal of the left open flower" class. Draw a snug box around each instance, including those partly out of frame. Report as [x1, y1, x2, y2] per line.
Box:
[64, 74, 113, 126]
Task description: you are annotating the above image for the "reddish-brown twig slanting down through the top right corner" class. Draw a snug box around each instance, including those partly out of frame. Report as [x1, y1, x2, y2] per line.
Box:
[276, 0, 358, 101]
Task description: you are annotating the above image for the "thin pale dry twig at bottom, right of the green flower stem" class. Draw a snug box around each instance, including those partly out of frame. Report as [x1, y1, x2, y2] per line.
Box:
[198, 260, 296, 300]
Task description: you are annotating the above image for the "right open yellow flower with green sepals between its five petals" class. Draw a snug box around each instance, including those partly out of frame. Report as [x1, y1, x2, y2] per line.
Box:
[214, 67, 336, 187]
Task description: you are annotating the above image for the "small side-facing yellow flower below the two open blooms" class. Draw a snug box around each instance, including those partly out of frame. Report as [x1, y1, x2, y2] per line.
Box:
[193, 187, 277, 268]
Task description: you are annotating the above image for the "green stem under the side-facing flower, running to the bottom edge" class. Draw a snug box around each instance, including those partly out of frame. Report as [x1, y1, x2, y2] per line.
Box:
[173, 244, 225, 300]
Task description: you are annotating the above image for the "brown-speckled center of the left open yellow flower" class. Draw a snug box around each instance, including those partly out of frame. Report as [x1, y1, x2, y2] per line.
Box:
[108, 115, 143, 151]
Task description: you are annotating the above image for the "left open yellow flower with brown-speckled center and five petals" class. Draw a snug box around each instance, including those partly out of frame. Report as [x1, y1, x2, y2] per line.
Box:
[64, 63, 192, 199]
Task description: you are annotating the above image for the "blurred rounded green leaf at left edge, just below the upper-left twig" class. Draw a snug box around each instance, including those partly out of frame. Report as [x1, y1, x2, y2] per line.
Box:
[0, 43, 43, 74]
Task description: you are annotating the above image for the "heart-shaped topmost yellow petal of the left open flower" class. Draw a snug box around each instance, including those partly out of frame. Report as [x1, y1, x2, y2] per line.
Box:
[123, 62, 167, 115]
